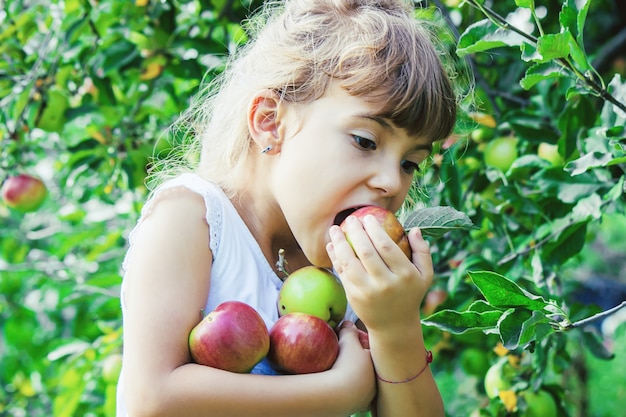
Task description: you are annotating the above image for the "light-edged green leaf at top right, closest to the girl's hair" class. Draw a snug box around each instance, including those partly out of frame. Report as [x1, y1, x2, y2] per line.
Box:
[456, 19, 525, 57]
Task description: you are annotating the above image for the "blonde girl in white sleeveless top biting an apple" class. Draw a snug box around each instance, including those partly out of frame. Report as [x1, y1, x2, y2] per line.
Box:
[118, 0, 456, 417]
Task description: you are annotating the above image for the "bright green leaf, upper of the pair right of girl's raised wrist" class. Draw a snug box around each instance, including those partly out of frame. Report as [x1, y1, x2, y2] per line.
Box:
[468, 271, 549, 310]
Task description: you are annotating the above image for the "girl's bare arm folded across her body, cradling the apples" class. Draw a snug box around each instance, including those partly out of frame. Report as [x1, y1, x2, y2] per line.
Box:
[124, 190, 375, 417]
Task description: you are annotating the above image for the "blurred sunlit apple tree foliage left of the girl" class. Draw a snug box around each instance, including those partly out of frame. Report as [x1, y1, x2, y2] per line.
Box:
[0, 0, 260, 417]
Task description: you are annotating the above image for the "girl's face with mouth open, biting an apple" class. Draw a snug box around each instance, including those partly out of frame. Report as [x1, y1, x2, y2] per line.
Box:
[271, 84, 431, 267]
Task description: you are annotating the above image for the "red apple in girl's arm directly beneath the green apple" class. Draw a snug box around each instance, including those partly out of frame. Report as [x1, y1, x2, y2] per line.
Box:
[267, 313, 339, 374]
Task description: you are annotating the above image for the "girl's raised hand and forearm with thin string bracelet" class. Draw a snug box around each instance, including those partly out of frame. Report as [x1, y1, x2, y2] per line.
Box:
[328, 214, 444, 417]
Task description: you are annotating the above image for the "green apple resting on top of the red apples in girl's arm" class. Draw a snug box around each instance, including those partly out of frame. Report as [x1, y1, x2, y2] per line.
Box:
[278, 266, 348, 329]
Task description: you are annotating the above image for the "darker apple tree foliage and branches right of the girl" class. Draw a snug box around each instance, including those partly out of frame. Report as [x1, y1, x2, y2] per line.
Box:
[408, 0, 626, 416]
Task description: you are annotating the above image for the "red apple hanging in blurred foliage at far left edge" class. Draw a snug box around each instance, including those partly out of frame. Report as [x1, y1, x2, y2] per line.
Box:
[2, 174, 48, 213]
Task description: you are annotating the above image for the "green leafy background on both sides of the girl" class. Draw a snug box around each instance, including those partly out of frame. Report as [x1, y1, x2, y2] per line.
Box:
[0, 0, 626, 417]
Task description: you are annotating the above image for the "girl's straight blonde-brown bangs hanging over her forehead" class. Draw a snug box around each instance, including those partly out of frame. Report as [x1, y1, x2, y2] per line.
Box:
[329, 14, 457, 142]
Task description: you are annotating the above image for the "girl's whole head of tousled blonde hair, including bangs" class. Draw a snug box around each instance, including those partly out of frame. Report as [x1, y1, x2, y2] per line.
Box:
[157, 0, 457, 196]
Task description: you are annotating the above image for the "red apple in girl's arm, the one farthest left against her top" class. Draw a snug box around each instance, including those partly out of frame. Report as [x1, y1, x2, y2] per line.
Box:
[189, 301, 270, 373]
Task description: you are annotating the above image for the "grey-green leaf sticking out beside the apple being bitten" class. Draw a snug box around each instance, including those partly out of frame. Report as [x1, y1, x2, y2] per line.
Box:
[404, 206, 476, 239]
